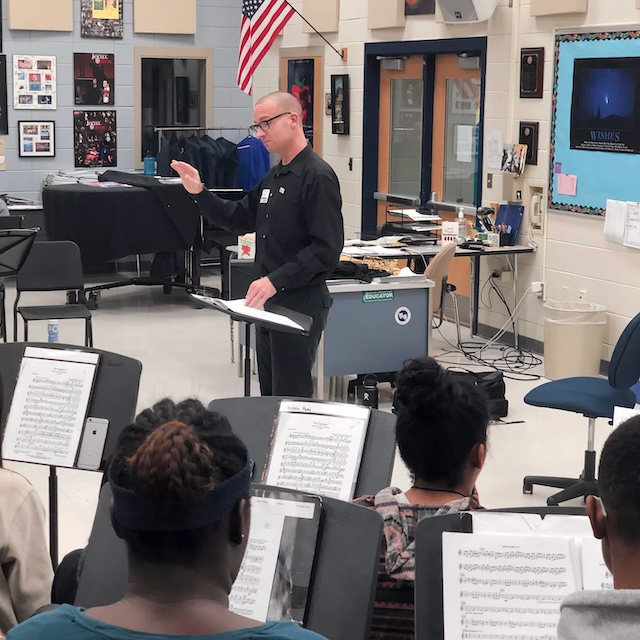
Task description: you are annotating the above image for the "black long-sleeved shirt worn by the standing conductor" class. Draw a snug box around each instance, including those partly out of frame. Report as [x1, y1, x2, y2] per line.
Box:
[192, 146, 344, 291]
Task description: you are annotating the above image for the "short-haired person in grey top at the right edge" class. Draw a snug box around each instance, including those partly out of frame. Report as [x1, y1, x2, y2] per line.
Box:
[558, 416, 640, 640]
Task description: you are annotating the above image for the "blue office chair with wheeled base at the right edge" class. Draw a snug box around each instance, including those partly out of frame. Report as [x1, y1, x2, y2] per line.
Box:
[522, 314, 640, 505]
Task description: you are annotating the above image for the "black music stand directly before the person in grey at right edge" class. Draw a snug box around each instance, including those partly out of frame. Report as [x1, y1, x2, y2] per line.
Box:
[415, 507, 585, 640]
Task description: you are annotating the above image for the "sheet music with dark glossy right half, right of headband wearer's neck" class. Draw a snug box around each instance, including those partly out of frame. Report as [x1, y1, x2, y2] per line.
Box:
[229, 487, 322, 624]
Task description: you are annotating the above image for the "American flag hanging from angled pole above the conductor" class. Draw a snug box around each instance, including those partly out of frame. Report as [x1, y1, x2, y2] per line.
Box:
[238, 0, 295, 95]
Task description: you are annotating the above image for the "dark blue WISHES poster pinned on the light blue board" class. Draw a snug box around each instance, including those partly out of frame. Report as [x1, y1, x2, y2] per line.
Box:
[570, 57, 640, 153]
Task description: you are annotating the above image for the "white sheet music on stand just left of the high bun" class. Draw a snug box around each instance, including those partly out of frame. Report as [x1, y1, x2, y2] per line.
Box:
[263, 400, 371, 500]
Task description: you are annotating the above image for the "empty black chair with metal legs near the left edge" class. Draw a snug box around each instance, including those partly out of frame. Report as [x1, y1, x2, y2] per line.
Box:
[13, 240, 93, 347]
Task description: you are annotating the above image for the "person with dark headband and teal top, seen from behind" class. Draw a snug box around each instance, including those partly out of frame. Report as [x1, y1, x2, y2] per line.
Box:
[7, 399, 322, 640]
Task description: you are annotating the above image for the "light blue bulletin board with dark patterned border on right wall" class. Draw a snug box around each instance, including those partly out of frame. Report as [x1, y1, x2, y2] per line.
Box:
[548, 31, 640, 215]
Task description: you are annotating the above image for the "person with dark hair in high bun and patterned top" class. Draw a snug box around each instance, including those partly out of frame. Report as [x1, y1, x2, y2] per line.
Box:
[356, 358, 489, 640]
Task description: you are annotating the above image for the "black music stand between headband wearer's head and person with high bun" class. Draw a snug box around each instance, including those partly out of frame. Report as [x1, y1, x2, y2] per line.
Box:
[207, 396, 396, 498]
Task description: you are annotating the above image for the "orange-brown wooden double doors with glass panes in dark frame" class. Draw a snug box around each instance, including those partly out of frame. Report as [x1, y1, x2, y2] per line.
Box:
[377, 53, 482, 302]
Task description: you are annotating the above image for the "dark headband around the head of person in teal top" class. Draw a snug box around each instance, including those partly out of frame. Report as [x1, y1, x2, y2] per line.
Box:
[109, 458, 253, 531]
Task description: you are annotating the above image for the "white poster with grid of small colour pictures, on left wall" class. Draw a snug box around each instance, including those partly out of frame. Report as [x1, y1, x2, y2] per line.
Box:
[13, 55, 56, 109]
